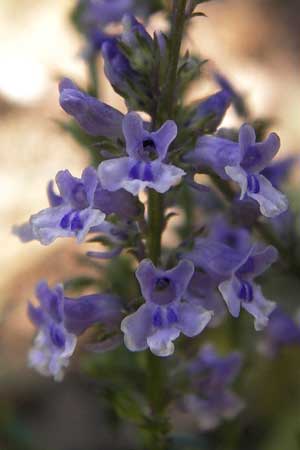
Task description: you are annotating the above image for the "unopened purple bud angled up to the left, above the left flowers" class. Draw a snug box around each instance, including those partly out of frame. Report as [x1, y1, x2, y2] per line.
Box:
[59, 78, 124, 139]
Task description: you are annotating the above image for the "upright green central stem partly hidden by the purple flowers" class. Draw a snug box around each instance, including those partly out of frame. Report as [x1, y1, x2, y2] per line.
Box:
[146, 0, 187, 450]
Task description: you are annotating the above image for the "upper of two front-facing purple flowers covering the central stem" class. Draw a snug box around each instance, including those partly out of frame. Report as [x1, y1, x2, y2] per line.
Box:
[98, 112, 185, 195]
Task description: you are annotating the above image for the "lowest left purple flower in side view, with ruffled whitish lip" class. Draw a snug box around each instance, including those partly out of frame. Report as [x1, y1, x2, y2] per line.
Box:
[28, 281, 121, 381]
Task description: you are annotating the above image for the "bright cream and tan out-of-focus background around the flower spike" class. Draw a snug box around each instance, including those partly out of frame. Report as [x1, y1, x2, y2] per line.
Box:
[0, 0, 300, 414]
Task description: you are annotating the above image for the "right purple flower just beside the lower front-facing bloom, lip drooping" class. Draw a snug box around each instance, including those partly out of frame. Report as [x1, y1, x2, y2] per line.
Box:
[184, 219, 278, 330]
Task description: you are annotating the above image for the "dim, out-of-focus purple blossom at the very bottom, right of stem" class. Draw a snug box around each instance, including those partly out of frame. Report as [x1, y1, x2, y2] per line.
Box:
[184, 345, 244, 431]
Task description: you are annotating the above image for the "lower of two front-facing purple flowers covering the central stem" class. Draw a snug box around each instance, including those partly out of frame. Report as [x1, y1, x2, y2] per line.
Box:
[121, 259, 212, 356]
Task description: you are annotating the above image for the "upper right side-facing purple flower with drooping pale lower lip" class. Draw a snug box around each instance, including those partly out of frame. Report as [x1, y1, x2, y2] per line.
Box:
[186, 124, 288, 217]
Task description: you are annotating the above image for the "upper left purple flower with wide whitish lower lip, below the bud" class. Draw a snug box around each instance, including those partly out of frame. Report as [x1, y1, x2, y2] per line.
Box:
[13, 167, 140, 245]
